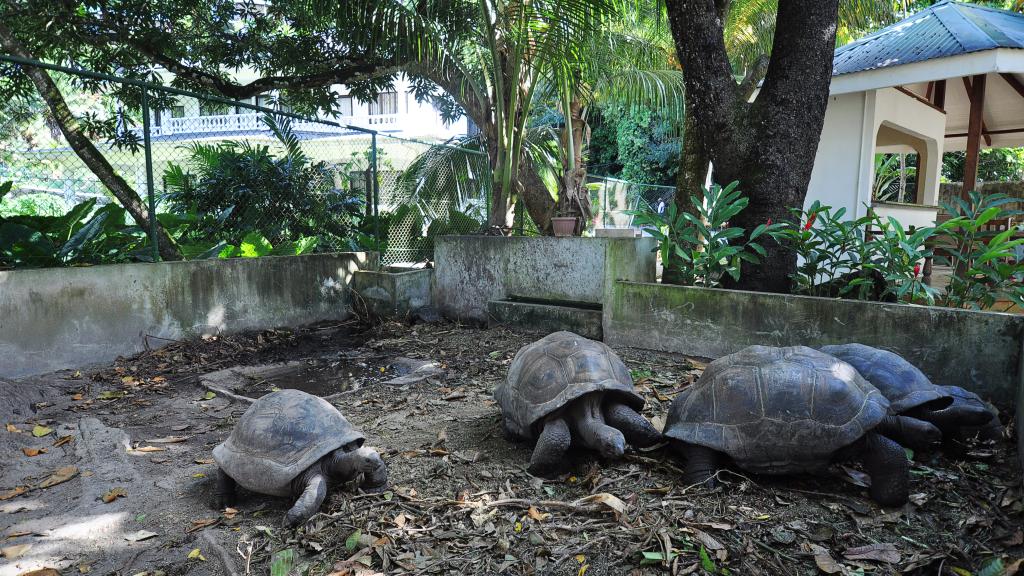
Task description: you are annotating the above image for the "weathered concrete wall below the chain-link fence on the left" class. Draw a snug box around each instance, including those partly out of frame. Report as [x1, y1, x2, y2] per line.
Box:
[0, 253, 366, 377]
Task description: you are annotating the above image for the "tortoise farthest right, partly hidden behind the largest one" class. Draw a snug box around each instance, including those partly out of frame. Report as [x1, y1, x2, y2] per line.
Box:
[821, 343, 998, 440]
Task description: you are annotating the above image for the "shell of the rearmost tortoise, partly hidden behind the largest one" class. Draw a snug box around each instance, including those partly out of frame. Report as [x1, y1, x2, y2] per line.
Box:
[821, 343, 953, 414]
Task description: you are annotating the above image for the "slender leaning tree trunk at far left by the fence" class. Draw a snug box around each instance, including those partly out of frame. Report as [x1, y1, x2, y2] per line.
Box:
[0, 24, 181, 260]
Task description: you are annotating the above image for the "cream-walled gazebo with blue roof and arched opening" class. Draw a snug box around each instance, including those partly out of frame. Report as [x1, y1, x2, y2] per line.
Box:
[807, 0, 1024, 227]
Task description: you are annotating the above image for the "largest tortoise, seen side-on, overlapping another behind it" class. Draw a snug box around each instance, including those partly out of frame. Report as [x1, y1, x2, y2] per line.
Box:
[665, 346, 938, 506]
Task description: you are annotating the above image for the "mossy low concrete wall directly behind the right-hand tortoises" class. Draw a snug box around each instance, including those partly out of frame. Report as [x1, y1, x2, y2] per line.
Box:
[604, 282, 1024, 406]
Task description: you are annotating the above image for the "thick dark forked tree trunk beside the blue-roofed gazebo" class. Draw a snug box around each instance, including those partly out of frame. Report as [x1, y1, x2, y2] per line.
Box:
[665, 0, 839, 292]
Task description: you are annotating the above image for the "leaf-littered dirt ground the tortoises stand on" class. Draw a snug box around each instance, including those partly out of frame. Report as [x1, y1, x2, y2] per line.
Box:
[0, 323, 1024, 576]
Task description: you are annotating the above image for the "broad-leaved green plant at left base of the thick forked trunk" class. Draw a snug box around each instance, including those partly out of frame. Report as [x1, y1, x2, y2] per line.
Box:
[628, 181, 780, 287]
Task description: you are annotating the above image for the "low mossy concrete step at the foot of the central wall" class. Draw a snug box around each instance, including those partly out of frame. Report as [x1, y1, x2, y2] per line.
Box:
[487, 300, 601, 340]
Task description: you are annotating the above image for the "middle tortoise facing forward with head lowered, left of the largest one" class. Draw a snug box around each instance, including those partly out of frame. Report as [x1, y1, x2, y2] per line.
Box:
[495, 332, 662, 477]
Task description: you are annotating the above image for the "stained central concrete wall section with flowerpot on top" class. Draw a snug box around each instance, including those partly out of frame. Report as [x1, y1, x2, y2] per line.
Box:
[433, 236, 654, 322]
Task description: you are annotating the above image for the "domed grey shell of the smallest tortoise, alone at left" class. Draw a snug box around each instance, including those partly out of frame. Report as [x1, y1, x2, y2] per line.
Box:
[213, 389, 365, 496]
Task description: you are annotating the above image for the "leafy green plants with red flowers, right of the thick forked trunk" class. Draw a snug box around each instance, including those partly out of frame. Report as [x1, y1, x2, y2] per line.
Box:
[772, 202, 935, 302]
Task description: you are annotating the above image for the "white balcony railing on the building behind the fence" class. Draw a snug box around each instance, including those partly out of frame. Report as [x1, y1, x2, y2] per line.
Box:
[152, 113, 402, 136]
